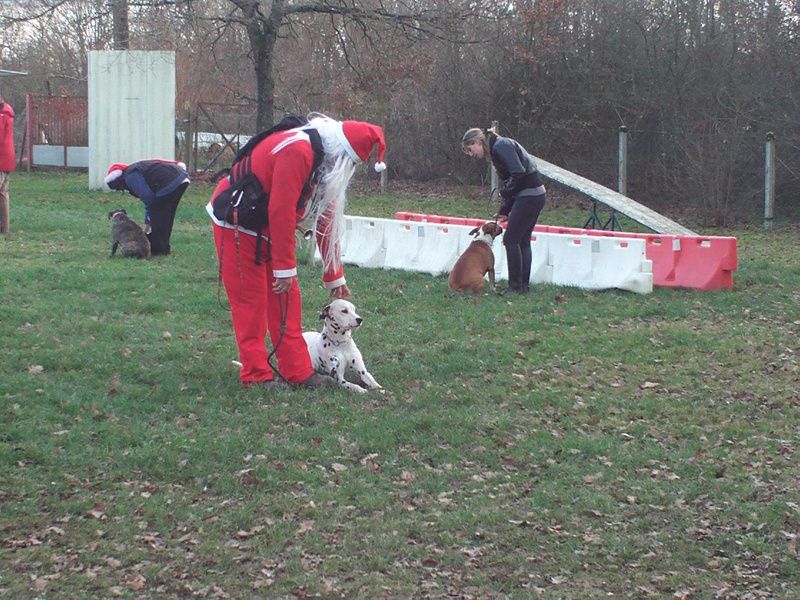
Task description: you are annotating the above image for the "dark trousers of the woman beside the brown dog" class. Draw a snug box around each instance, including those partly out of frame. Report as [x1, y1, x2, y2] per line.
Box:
[503, 194, 547, 291]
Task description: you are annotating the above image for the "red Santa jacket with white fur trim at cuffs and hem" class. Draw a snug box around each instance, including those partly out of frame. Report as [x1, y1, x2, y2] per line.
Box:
[206, 130, 345, 289]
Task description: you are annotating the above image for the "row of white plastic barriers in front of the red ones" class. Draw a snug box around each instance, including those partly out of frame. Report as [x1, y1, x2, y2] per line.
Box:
[316, 216, 653, 294]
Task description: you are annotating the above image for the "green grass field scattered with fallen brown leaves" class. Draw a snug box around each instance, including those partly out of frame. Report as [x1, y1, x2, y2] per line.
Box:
[0, 173, 800, 599]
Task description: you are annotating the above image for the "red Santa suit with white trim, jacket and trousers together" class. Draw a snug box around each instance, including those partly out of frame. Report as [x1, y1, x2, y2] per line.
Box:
[206, 130, 345, 384]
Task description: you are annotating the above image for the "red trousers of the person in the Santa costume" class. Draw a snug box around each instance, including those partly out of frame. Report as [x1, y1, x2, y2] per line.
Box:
[213, 224, 314, 385]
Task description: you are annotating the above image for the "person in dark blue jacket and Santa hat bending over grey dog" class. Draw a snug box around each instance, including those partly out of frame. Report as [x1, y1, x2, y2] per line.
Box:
[105, 159, 189, 255]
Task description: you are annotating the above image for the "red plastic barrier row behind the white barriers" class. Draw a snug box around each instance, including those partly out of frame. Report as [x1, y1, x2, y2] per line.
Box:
[395, 212, 739, 290]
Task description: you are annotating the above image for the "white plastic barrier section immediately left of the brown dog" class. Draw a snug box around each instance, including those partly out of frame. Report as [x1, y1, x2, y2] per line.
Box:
[383, 221, 461, 275]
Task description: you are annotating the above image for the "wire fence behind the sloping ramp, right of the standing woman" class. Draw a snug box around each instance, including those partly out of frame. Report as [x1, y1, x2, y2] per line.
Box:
[500, 121, 800, 225]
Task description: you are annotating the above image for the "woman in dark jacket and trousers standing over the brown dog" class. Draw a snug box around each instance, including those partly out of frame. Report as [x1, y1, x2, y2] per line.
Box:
[461, 127, 547, 294]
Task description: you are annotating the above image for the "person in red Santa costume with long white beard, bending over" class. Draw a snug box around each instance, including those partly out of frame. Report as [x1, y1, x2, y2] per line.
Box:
[206, 113, 386, 388]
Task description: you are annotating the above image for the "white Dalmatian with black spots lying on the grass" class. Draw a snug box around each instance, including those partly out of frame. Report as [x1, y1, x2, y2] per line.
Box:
[303, 300, 383, 394]
